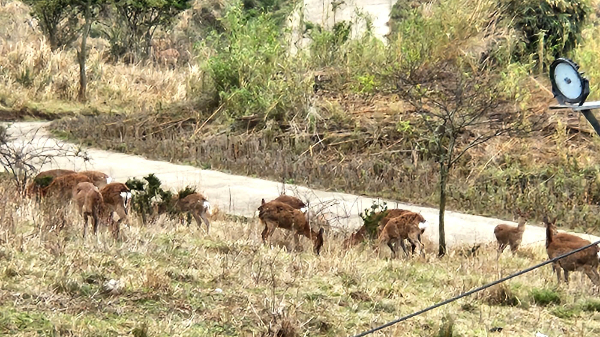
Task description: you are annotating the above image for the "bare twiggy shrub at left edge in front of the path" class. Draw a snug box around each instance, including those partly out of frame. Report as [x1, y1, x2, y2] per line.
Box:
[0, 126, 89, 195]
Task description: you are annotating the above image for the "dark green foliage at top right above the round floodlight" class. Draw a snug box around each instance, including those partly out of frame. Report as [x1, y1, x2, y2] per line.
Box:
[503, 0, 591, 64]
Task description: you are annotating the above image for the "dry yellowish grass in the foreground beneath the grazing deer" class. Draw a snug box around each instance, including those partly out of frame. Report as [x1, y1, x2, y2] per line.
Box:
[0, 177, 600, 336]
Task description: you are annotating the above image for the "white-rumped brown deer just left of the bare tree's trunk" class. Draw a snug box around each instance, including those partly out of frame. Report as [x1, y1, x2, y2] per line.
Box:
[377, 212, 427, 257]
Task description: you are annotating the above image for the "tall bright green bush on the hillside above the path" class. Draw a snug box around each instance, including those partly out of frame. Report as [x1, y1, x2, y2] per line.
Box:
[206, 5, 310, 124]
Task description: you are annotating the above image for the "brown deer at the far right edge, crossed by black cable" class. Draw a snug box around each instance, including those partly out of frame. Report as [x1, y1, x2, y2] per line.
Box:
[543, 216, 600, 286]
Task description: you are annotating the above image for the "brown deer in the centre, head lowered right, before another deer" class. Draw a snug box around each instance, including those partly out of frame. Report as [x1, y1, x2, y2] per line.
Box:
[258, 199, 323, 255]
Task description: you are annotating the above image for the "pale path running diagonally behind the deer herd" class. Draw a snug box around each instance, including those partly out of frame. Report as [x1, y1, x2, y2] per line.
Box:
[8, 122, 598, 246]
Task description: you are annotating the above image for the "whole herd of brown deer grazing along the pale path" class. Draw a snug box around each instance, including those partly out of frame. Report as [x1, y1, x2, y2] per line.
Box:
[26, 169, 600, 286]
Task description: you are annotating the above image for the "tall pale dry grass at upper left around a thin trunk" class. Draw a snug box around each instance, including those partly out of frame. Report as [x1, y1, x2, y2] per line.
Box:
[0, 1, 202, 112]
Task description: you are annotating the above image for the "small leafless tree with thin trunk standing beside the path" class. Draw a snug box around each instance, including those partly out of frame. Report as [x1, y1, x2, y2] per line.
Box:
[398, 62, 538, 256]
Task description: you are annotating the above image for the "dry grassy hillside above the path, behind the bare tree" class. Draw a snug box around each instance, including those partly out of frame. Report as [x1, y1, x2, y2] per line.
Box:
[0, 0, 600, 233]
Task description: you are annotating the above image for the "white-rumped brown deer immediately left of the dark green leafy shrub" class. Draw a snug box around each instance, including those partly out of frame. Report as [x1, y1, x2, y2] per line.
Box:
[100, 183, 131, 239]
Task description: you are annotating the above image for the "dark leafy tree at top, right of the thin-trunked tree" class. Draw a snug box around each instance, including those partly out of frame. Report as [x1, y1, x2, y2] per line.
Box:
[113, 0, 192, 57]
